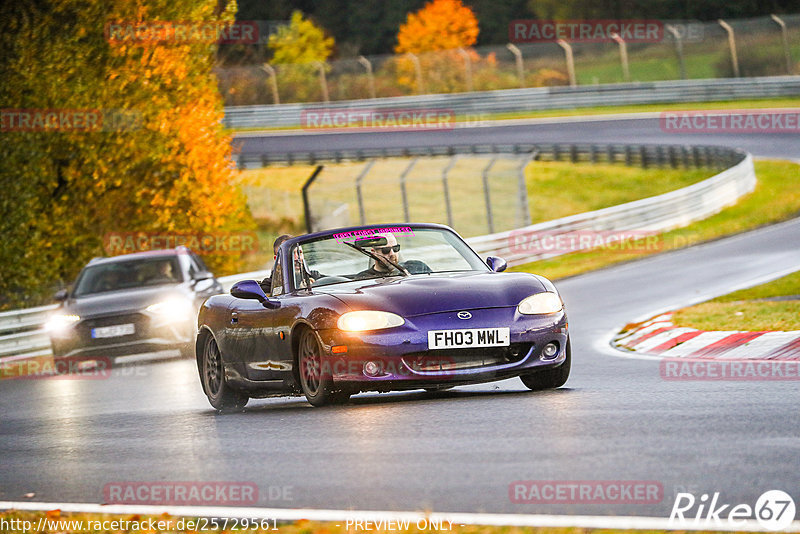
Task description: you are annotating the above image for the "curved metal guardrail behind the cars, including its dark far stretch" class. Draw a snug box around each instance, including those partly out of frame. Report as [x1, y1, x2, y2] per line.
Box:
[0, 145, 756, 364]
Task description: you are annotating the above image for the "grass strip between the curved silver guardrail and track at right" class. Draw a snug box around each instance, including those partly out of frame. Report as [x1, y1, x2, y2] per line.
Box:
[510, 161, 800, 279]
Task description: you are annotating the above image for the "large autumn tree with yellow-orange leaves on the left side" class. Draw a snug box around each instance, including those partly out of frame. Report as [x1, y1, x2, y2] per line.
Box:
[0, 0, 252, 308]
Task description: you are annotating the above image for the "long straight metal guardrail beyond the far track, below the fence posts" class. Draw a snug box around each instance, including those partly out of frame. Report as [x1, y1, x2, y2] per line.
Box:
[223, 76, 800, 128]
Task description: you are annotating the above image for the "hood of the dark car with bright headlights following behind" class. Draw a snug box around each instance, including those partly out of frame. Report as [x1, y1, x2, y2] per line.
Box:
[63, 284, 190, 317]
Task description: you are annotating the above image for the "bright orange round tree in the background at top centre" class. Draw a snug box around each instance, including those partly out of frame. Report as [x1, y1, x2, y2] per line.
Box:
[395, 0, 480, 92]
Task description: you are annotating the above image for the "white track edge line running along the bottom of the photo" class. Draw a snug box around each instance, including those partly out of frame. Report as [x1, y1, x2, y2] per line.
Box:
[0, 501, 800, 532]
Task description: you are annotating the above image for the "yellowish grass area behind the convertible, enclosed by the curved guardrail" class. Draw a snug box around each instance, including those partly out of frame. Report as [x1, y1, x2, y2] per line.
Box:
[242, 157, 713, 269]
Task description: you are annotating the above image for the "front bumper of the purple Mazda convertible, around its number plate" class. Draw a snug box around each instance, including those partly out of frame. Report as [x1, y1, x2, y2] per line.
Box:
[319, 307, 568, 391]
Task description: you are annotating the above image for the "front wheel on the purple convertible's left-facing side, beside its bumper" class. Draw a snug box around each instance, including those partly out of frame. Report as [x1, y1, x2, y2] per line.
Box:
[297, 328, 350, 406]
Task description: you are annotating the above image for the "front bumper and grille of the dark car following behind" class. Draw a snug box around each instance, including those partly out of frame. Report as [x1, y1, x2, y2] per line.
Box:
[50, 312, 196, 358]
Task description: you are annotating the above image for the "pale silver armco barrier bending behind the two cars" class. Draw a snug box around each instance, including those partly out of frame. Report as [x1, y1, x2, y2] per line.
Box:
[0, 147, 756, 363]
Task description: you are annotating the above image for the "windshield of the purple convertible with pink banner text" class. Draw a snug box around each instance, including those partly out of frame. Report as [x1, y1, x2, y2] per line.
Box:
[289, 227, 488, 289]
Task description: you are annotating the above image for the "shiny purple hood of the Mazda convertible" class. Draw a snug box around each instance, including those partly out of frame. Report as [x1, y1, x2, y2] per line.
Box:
[315, 272, 546, 317]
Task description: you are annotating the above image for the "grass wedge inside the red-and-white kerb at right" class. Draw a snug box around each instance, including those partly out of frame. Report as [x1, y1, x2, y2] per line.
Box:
[673, 271, 800, 331]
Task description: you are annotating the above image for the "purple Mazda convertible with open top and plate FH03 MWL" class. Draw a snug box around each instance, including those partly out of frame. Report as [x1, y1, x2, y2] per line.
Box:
[196, 224, 571, 410]
